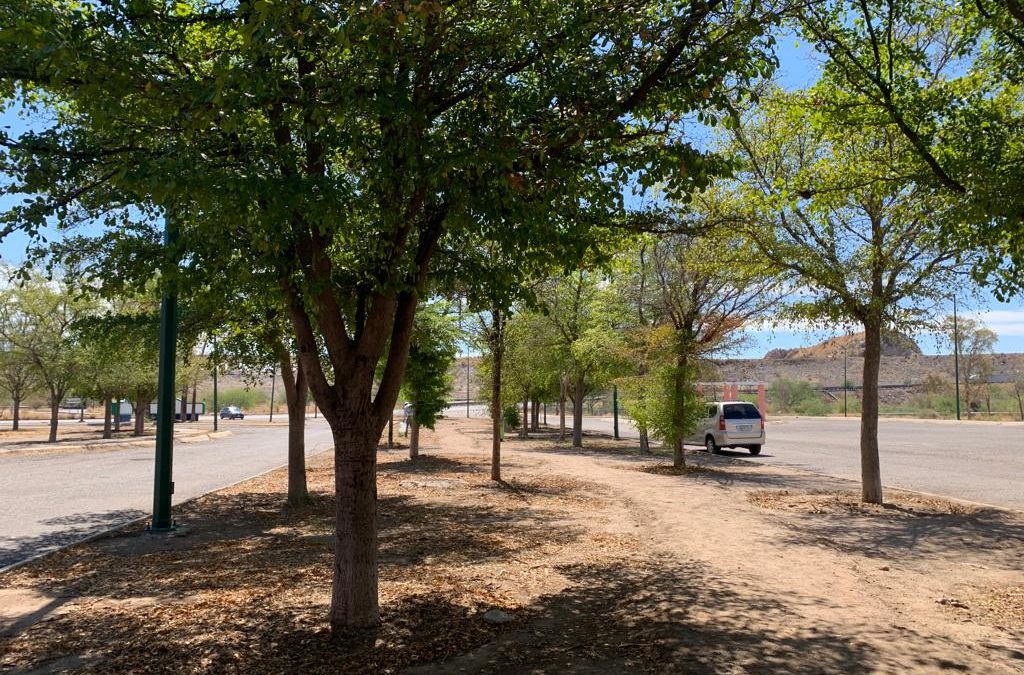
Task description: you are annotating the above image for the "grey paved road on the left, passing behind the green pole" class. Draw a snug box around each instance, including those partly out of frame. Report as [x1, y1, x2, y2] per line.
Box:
[0, 418, 331, 567]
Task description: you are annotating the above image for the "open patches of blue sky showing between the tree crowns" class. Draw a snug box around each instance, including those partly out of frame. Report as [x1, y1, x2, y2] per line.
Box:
[0, 30, 1024, 357]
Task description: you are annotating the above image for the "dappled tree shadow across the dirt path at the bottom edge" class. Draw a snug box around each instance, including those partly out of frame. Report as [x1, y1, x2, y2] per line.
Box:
[411, 561, 970, 674]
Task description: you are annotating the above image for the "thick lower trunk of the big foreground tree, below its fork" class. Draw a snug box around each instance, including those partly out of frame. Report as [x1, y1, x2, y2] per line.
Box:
[324, 422, 380, 630]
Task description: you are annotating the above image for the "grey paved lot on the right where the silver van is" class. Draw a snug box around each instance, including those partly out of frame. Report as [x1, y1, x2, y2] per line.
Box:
[561, 416, 1024, 510]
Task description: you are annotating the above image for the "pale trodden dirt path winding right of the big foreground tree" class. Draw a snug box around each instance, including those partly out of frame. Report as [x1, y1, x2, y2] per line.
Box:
[409, 420, 1024, 673]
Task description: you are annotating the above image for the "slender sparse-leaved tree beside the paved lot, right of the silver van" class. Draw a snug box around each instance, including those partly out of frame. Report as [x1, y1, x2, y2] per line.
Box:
[733, 89, 974, 503]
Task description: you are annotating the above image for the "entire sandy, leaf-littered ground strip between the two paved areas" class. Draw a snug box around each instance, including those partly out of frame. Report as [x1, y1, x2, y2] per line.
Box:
[0, 419, 1024, 673]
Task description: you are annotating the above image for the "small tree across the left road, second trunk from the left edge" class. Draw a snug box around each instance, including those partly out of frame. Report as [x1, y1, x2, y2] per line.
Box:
[0, 277, 93, 442]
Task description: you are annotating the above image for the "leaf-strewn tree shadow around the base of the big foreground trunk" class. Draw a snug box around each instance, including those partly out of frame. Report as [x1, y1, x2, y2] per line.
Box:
[0, 477, 581, 673]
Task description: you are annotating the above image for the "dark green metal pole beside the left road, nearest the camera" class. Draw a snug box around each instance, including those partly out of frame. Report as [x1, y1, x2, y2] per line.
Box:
[150, 218, 178, 532]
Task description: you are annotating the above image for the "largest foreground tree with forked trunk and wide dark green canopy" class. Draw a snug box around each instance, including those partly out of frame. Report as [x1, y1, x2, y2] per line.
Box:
[0, 0, 777, 629]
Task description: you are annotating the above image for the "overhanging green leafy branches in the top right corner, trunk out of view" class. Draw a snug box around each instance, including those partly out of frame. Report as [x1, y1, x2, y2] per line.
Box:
[799, 0, 1024, 299]
